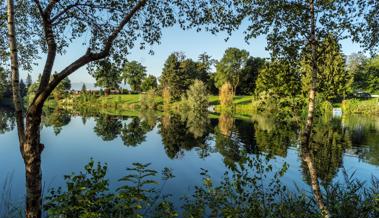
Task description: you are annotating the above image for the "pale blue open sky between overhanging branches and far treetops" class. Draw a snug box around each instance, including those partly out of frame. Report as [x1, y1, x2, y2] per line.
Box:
[21, 22, 361, 84]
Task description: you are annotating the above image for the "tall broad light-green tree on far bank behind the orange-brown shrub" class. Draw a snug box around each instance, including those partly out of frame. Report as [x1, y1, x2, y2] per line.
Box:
[215, 48, 249, 93]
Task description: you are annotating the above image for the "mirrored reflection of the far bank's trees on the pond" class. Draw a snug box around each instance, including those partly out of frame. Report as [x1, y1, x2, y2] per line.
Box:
[0, 108, 379, 215]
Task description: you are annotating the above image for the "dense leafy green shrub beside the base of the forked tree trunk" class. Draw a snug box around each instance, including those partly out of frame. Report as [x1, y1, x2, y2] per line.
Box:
[44, 160, 114, 218]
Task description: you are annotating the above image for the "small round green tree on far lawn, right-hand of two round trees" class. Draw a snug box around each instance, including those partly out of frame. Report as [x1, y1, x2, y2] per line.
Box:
[122, 61, 146, 92]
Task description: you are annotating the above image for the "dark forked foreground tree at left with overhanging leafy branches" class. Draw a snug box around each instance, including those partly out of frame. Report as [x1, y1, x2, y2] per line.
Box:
[0, 0, 233, 217]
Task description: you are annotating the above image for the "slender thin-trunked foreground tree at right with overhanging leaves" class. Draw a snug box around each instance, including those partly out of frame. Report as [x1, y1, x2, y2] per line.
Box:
[219, 0, 379, 153]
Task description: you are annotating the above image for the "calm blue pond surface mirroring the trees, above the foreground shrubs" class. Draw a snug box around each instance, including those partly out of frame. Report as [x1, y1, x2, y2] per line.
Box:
[0, 108, 379, 206]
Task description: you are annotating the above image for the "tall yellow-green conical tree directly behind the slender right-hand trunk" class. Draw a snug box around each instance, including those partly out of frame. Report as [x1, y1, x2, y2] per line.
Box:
[301, 36, 353, 101]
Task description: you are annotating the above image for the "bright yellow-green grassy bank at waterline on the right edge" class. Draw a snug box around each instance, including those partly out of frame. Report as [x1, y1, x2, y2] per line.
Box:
[341, 98, 379, 115]
